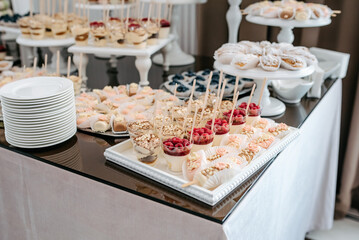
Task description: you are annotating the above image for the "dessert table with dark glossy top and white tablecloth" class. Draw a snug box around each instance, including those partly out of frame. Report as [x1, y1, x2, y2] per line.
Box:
[0, 55, 342, 240]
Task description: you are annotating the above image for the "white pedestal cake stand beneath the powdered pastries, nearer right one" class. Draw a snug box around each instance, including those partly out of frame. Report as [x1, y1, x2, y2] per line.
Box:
[214, 61, 314, 117]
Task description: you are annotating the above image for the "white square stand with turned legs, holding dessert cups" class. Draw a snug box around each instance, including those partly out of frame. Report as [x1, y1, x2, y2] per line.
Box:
[68, 35, 174, 88]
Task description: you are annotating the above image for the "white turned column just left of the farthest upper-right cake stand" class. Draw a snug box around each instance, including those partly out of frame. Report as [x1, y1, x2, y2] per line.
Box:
[226, 0, 242, 43]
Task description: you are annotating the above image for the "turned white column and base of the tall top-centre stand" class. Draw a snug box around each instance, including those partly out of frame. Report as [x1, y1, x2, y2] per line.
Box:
[152, 4, 194, 66]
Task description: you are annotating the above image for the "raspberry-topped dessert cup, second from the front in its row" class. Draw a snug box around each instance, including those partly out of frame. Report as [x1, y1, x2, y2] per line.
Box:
[192, 127, 214, 152]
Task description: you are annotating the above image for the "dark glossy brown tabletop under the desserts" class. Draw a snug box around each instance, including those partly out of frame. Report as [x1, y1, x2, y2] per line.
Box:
[0, 54, 335, 223]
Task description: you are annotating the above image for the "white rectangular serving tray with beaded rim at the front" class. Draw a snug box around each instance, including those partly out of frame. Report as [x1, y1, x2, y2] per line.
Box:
[104, 127, 299, 206]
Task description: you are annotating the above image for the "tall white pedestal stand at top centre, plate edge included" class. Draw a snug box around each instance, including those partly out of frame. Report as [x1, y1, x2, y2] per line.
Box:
[141, 0, 207, 66]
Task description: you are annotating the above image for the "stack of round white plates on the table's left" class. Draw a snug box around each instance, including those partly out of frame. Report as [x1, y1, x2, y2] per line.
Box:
[0, 77, 76, 148]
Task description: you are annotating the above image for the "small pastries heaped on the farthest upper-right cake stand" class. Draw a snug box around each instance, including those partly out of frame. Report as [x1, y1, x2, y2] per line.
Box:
[243, 0, 340, 22]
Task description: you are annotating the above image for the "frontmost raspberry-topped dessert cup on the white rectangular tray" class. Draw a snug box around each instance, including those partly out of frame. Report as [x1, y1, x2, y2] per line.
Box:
[162, 137, 193, 172]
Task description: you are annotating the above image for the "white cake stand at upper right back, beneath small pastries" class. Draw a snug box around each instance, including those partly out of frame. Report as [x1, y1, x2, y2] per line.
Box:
[246, 15, 332, 43]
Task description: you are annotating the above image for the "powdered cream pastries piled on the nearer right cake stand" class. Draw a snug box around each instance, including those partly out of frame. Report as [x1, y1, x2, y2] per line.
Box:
[214, 41, 318, 72]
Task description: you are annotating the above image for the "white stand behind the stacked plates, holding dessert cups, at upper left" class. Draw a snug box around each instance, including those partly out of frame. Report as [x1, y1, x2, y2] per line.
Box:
[16, 35, 76, 74]
